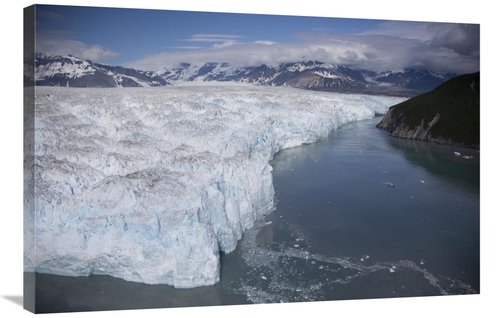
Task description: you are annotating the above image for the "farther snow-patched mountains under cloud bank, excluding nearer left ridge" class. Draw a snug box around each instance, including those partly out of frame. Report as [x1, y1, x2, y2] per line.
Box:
[158, 61, 457, 95]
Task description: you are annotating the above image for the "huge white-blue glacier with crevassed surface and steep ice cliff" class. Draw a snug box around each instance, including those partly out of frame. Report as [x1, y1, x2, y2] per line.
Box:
[24, 82, 405, 288]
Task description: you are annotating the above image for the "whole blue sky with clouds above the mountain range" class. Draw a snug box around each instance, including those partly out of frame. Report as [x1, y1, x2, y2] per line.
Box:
[36, 5, 480, 73]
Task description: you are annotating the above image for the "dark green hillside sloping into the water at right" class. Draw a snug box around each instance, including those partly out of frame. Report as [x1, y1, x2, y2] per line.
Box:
[377, 72, 479, 148]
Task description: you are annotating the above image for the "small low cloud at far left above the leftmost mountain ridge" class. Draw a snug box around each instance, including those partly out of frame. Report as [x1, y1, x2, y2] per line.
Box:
[36, 31, 119, 62]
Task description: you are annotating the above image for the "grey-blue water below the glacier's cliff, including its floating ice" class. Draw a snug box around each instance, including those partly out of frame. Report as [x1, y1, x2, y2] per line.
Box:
[36, 118, 479, 312]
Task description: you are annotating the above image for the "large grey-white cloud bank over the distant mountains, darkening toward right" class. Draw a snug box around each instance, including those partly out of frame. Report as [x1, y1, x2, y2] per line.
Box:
[126, 21, 479, 73]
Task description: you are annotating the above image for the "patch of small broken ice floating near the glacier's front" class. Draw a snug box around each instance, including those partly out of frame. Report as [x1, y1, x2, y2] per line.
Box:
[232, 216, 477, 303]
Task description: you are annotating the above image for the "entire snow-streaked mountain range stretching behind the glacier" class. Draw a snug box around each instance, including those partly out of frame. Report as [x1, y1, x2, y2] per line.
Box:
[24, 54, 458, 96]
